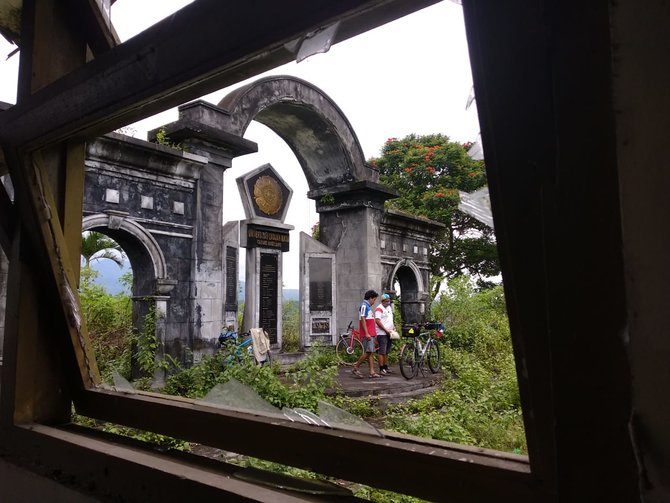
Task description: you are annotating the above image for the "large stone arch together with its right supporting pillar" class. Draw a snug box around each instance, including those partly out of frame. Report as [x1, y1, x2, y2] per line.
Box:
[214, 76, 396, 335]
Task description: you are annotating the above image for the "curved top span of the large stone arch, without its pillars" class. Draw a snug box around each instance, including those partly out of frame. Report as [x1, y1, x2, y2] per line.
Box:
[219, 76, 378, 191]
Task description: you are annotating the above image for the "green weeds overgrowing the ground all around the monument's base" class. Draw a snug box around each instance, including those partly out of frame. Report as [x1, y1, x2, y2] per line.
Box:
[81, 273, 526, 453]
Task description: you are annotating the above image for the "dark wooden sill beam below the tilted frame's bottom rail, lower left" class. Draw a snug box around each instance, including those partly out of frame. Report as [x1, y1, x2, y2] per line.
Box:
[6, 424, 361, 503]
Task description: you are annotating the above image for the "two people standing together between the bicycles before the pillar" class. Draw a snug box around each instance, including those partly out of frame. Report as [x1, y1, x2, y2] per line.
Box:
[351, 290, 393, 378]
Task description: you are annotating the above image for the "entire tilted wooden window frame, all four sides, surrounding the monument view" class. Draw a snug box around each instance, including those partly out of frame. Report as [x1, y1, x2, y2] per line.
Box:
[0, 0, 608, 502]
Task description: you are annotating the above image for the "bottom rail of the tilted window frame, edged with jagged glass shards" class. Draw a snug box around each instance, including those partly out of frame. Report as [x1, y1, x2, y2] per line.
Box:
[75, 390, 540, 502]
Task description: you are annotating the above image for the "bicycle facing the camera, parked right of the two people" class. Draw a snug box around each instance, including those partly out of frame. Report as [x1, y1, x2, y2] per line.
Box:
[400, 322, 444, 380]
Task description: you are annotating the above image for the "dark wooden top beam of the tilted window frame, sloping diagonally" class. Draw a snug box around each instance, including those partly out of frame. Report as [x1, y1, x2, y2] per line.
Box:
[0, 0, 436, 150]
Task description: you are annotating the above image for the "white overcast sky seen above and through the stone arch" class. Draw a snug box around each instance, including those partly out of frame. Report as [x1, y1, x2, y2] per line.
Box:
[0, 0, 479, 288]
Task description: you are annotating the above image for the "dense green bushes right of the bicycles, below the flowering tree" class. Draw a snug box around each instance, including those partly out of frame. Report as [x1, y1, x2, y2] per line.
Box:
[385, 277, 526, 452]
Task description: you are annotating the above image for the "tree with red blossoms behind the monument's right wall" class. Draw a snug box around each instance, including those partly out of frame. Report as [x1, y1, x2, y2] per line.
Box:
[369, 134, 500, 296]
